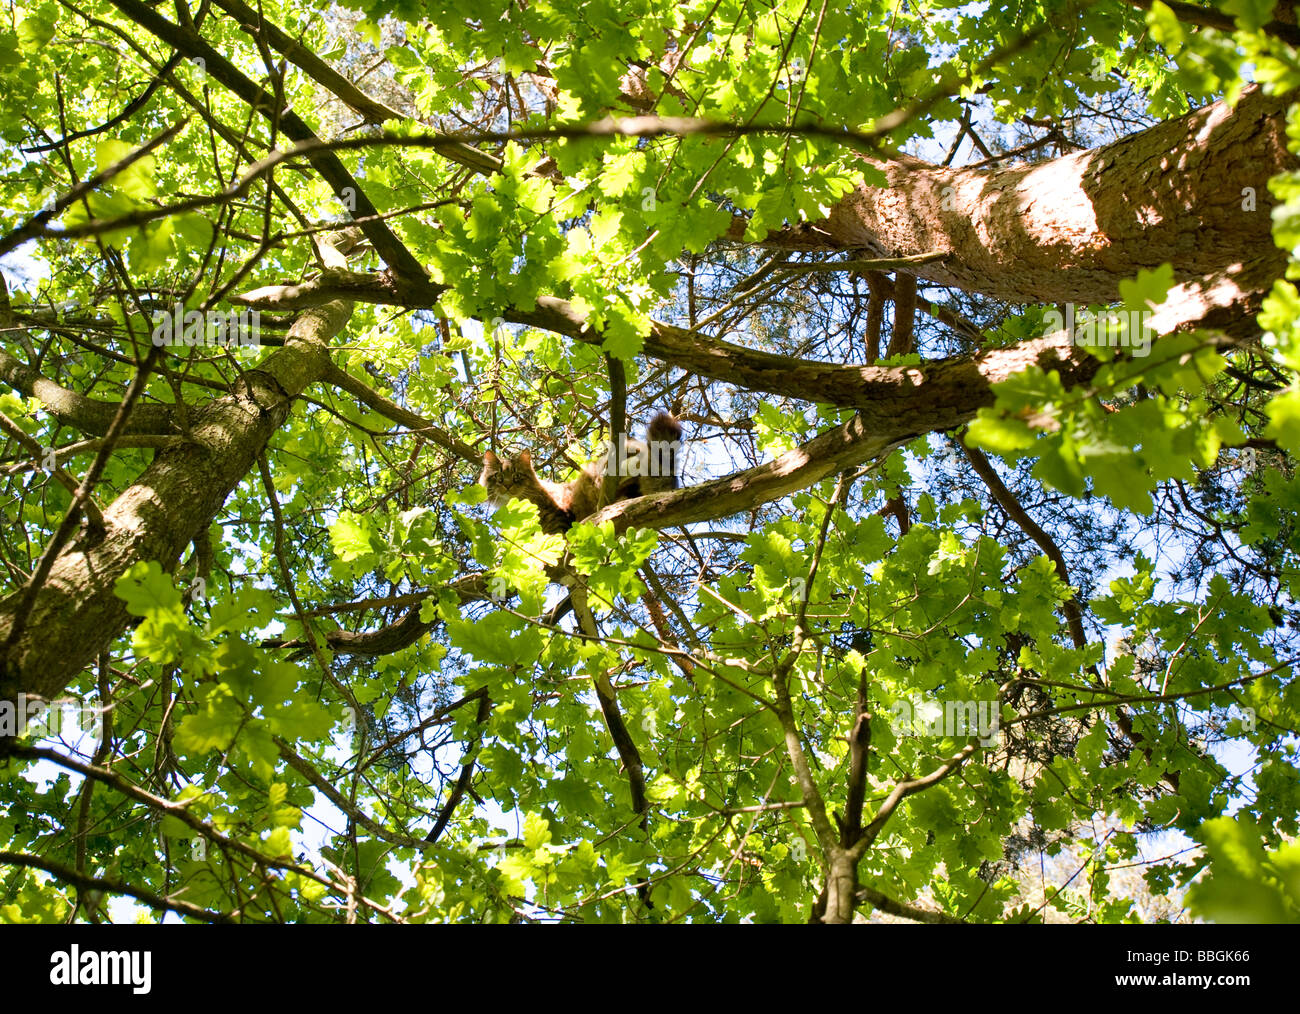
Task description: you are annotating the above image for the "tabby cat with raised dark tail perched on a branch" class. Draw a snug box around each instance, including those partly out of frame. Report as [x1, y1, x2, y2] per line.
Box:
[478, 412, 681, 536]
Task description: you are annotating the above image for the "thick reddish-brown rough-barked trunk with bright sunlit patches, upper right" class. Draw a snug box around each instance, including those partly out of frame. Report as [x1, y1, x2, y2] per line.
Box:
[736, 86, 1297, 325]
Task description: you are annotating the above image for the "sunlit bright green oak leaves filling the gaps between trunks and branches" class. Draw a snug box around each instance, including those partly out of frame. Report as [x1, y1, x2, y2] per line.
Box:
[0, 0, 1300, 922]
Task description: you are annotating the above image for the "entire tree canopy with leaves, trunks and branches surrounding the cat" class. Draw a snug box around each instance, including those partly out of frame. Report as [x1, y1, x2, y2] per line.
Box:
[0, 0, 1300, 922]
